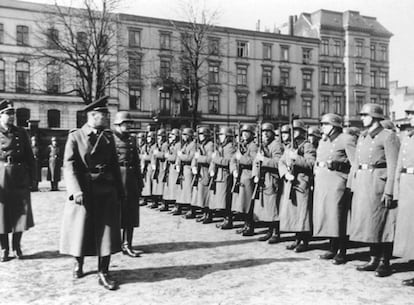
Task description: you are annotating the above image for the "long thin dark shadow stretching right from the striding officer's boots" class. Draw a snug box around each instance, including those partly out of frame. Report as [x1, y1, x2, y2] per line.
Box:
[111, 257, 309, 284]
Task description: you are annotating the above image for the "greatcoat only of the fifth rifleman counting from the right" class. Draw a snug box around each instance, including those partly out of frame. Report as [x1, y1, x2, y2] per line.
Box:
[191, 140, 214, 208]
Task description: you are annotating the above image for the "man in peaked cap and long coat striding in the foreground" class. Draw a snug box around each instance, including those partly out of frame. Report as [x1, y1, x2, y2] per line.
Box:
[60, 96, 124, 290]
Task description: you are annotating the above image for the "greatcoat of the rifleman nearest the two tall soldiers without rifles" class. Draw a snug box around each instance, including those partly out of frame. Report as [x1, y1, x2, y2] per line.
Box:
[279, 139, 316, 232]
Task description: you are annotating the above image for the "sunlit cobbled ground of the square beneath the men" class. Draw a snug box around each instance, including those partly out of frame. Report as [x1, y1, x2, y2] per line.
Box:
[0, 184, 414, 305]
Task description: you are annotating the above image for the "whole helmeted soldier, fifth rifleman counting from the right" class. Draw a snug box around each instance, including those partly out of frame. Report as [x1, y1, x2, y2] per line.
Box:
[191, 127, 215, 224]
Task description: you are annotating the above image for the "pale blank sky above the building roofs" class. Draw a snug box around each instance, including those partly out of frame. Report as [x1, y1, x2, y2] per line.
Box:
[28, 0, 414, 86]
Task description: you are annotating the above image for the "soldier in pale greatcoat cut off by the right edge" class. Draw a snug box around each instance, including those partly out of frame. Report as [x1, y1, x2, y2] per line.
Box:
[394, 104, 414, 286]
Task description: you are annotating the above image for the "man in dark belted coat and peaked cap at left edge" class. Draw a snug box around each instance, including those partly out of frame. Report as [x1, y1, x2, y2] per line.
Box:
[0, 100, 34, 262]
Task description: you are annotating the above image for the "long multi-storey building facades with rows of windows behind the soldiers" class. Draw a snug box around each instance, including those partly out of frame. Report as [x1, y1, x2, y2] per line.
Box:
[0, 0, 391, 130]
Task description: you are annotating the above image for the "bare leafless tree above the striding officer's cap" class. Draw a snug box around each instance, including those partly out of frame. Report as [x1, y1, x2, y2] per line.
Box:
[38, 0, 127, 104]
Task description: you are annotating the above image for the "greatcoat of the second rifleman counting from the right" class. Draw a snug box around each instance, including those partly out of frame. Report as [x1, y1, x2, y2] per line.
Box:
[252, 139, 283, 222]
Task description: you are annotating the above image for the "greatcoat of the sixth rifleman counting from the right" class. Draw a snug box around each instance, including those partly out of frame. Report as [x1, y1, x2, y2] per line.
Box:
[174, 141, 195, 204]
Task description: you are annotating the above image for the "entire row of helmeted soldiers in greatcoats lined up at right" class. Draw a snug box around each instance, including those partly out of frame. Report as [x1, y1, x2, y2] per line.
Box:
[138, 104, 414, 286]
